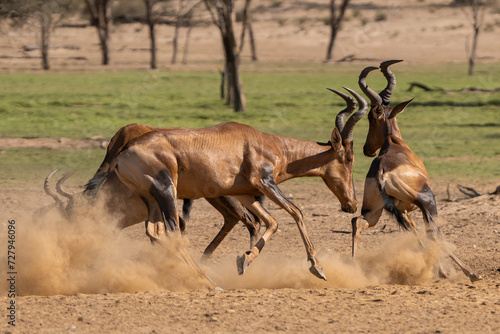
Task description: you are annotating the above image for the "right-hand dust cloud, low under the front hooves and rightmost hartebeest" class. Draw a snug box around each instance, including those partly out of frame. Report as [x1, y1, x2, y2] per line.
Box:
[207, 233, 453, 289]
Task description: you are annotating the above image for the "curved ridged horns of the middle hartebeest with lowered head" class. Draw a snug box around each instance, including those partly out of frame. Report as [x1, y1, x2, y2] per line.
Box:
[327, 87, 368, 141]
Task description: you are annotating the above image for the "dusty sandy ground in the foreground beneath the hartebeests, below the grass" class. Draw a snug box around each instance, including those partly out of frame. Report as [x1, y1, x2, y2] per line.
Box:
[0, 182, 500, 333]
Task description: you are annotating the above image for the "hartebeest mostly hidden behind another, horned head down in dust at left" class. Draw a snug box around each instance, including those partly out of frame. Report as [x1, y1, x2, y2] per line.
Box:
[44, 123, 260, 259]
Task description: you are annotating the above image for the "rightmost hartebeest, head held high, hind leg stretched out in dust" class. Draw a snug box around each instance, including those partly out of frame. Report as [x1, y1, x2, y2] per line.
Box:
[352, 60, 480, 281]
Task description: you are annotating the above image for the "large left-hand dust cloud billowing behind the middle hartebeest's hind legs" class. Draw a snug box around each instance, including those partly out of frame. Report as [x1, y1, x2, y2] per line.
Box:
[0, 205, 209, 296]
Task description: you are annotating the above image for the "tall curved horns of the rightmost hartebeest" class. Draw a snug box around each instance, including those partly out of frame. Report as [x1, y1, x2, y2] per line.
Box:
[358, 60, 402, 106]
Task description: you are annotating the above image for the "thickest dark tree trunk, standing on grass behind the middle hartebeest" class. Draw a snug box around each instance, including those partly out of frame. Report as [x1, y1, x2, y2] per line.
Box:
[204, 0, 246, 112]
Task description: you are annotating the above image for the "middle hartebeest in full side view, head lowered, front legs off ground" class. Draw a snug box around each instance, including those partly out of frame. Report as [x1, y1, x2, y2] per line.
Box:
[88, 91, 367, 279]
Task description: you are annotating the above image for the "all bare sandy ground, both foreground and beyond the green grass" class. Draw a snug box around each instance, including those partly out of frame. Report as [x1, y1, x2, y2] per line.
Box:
[0, 0, 500, 333]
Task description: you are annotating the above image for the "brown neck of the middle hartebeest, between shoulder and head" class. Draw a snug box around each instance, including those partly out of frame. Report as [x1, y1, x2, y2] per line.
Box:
[276, 138, 335, 183]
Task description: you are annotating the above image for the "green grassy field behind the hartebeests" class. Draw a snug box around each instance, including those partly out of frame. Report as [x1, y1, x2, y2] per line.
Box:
[0, 63, 500, 186]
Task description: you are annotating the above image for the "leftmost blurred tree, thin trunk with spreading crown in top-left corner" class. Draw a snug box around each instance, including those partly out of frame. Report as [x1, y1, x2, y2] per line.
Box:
[0, 0, 77, 70]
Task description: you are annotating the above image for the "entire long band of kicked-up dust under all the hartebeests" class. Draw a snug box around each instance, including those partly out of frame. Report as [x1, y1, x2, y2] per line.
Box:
[0, 198, 454, 296]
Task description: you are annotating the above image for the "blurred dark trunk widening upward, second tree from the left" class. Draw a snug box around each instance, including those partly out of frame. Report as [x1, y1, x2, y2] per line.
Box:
[85, 0, 112, 65]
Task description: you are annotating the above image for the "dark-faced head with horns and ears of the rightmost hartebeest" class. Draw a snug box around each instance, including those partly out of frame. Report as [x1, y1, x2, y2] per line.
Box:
[358, 60, 413, 157]
